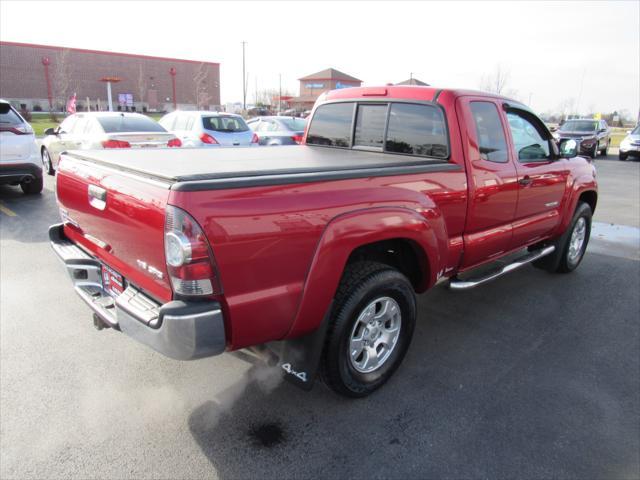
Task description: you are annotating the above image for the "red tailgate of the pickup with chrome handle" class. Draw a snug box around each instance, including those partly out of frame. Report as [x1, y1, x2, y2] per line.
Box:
[56, 154, 172, 302]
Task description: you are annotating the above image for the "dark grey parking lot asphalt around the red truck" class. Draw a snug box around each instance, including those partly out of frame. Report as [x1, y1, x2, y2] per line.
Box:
[0, 152, 640, 479]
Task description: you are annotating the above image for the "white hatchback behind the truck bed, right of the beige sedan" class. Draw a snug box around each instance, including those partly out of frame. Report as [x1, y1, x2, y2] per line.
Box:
[160, 110, 259, 147]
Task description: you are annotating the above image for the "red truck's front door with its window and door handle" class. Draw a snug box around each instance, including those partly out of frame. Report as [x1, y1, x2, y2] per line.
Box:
[505, 107, 569, 249]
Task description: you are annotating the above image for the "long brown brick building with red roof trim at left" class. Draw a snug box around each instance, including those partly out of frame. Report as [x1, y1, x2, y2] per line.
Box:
[0, 41, 220, 112]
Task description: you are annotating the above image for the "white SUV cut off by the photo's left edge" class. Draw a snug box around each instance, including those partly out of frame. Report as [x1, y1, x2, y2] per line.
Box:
[0, 100, 42, 194]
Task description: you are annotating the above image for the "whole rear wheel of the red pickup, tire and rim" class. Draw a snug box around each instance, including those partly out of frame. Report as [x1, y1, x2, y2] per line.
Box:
[321, 261, 416, 397]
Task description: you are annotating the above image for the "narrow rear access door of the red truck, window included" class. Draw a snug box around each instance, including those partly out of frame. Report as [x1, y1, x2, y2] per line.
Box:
[457, 97, 518, 269]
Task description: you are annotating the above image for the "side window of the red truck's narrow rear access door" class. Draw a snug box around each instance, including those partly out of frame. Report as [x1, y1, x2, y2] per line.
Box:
[470, 102, 509, 163]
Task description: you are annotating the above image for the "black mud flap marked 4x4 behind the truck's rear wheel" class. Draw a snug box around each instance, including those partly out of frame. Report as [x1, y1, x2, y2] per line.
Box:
[278, 303, 333, 391]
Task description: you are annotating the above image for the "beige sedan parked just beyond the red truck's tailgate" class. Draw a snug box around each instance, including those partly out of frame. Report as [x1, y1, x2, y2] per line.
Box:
[40, 112, 181, 175]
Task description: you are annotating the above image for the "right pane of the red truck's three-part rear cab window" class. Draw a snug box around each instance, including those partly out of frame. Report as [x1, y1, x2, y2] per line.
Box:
[385, 103, 449, 158]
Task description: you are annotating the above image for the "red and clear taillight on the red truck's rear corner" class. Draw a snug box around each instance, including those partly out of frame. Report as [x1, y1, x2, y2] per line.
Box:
[164, 205, 222, 297]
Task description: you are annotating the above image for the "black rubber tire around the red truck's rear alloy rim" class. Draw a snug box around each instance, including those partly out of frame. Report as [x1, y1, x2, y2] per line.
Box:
[320, 261, 416, 398]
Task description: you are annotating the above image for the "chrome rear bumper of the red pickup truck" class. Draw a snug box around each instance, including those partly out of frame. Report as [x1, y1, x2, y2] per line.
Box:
[49, 224, 226, 360]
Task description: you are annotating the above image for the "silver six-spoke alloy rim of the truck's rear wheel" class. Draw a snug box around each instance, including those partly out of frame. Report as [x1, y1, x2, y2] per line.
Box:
[349, 297, 402, 373]
